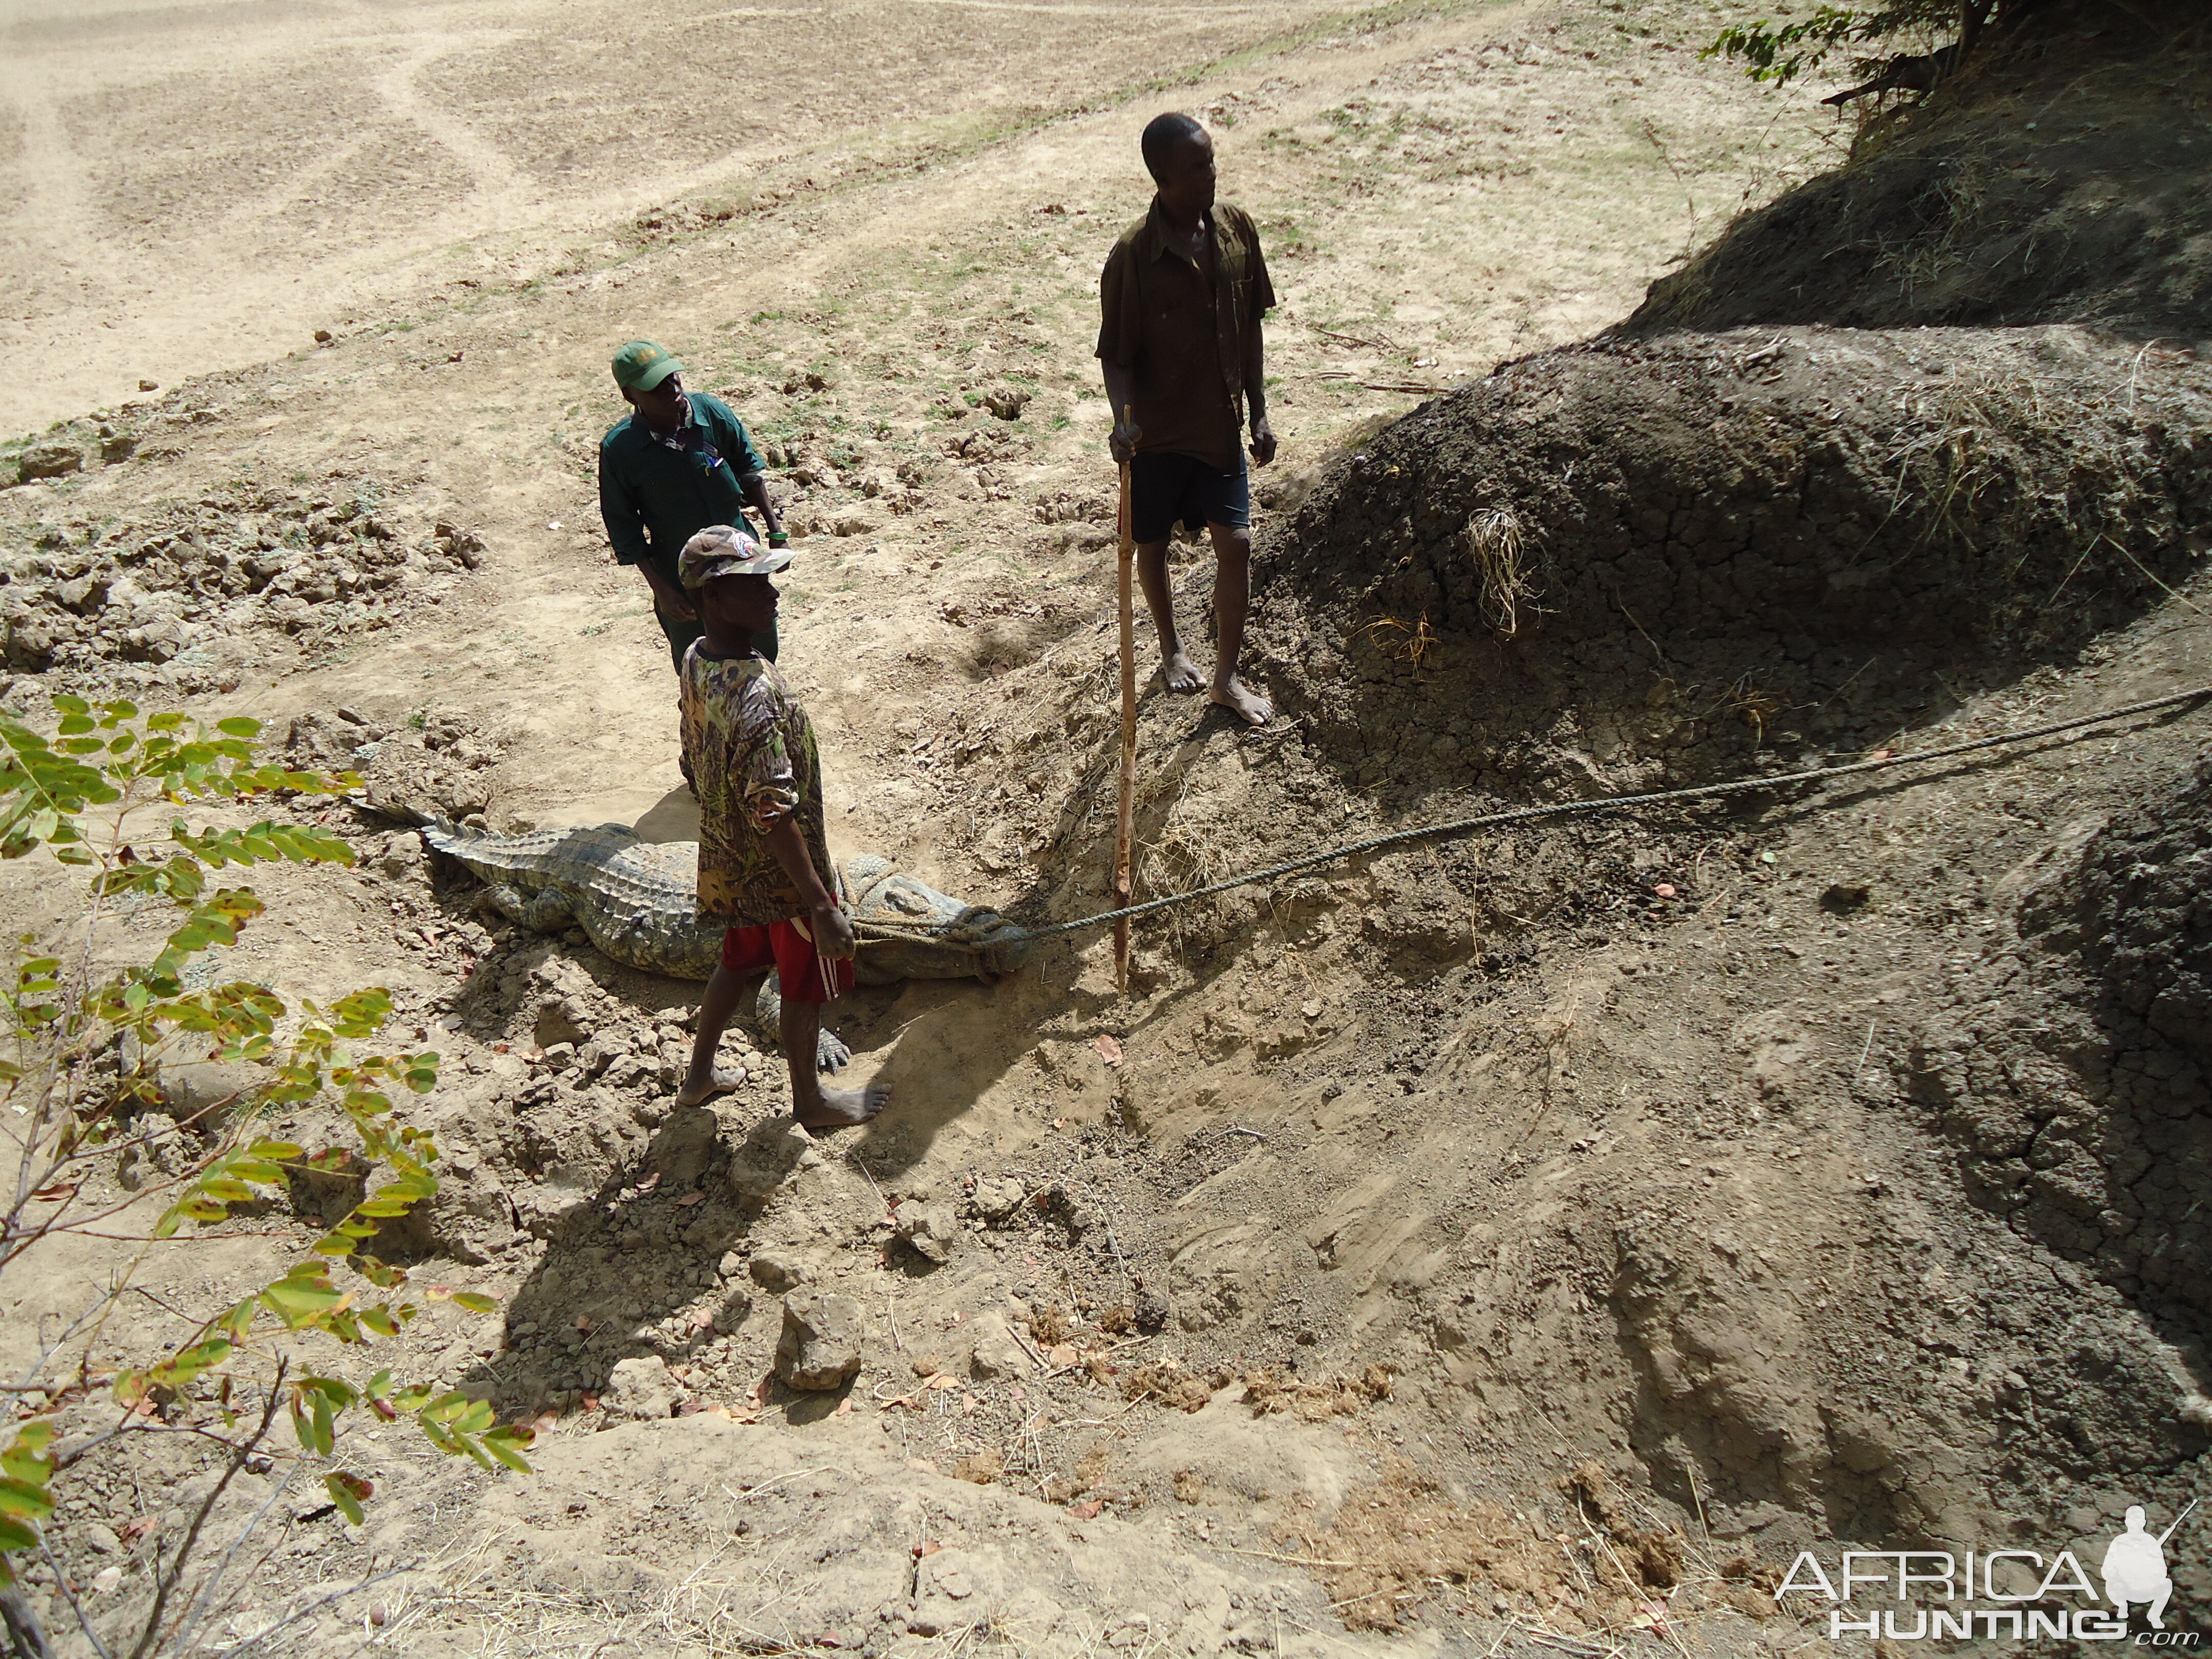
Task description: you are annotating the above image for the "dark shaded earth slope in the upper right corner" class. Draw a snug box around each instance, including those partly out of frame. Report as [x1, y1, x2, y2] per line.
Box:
[1626, 5, 2212, 341]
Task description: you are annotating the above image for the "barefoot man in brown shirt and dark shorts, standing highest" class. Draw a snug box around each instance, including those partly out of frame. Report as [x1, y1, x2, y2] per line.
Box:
[1097, 115, 1274, 726]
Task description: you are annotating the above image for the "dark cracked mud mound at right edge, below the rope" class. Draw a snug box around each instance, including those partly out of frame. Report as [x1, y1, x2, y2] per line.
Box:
[1916, 761, 2212, 1345]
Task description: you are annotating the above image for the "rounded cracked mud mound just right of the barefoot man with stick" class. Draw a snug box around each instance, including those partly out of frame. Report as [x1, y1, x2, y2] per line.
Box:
[1261, 327, 2212, 792]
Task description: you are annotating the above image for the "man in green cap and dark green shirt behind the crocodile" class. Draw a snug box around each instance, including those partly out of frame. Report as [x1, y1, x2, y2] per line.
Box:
[600, 341, 790, 675]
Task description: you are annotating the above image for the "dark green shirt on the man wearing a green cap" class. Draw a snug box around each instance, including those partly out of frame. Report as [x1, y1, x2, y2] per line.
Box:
[600, 392, 768, 586]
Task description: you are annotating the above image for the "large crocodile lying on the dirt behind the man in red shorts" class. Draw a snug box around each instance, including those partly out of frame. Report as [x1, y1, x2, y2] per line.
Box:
[418, 821, 1029, 1071]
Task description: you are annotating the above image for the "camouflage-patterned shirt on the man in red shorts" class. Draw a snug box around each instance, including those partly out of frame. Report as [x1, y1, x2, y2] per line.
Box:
[679, 642, 836, 927]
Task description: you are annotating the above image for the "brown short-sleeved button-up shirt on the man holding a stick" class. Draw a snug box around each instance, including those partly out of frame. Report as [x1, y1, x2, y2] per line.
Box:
[1097, 199, 1274, 473]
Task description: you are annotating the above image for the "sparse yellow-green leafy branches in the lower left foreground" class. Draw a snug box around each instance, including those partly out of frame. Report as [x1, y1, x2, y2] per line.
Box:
[0, 697, 531, 1652]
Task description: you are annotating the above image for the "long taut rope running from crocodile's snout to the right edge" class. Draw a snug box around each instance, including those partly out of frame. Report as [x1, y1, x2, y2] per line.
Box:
[860, 686, 2212, 945]
